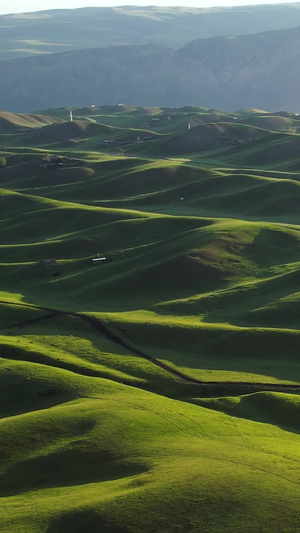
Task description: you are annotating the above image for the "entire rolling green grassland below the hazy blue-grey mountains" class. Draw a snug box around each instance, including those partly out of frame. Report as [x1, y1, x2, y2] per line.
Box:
[0, 105, 300, 533]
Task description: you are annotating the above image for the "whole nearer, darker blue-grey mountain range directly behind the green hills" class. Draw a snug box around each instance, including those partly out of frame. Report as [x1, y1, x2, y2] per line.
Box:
[0, 28, 300, 112]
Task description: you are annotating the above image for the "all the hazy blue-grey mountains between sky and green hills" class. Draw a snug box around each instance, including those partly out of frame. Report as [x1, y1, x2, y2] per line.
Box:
[0, 3, 300, 112]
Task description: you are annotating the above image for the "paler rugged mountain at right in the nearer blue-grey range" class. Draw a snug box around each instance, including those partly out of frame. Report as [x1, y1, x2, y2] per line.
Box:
[180, 27, 300, 110]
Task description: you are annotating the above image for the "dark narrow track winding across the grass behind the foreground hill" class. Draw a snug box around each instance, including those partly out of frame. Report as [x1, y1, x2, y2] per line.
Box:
[0, 300, 300, 395]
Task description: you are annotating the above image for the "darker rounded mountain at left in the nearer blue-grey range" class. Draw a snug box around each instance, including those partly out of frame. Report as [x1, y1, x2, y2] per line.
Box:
[0, 45, 221, 111]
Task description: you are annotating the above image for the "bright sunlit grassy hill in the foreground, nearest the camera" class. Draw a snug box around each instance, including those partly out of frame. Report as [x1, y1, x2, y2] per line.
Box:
[1, 370, 300, 533]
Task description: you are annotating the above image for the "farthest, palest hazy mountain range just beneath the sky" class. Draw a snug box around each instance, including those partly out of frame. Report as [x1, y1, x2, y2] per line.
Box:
[0, 3, 300, 60]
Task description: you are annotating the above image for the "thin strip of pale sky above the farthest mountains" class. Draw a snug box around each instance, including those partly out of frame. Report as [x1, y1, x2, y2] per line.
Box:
[0, 0, 291, 15]
